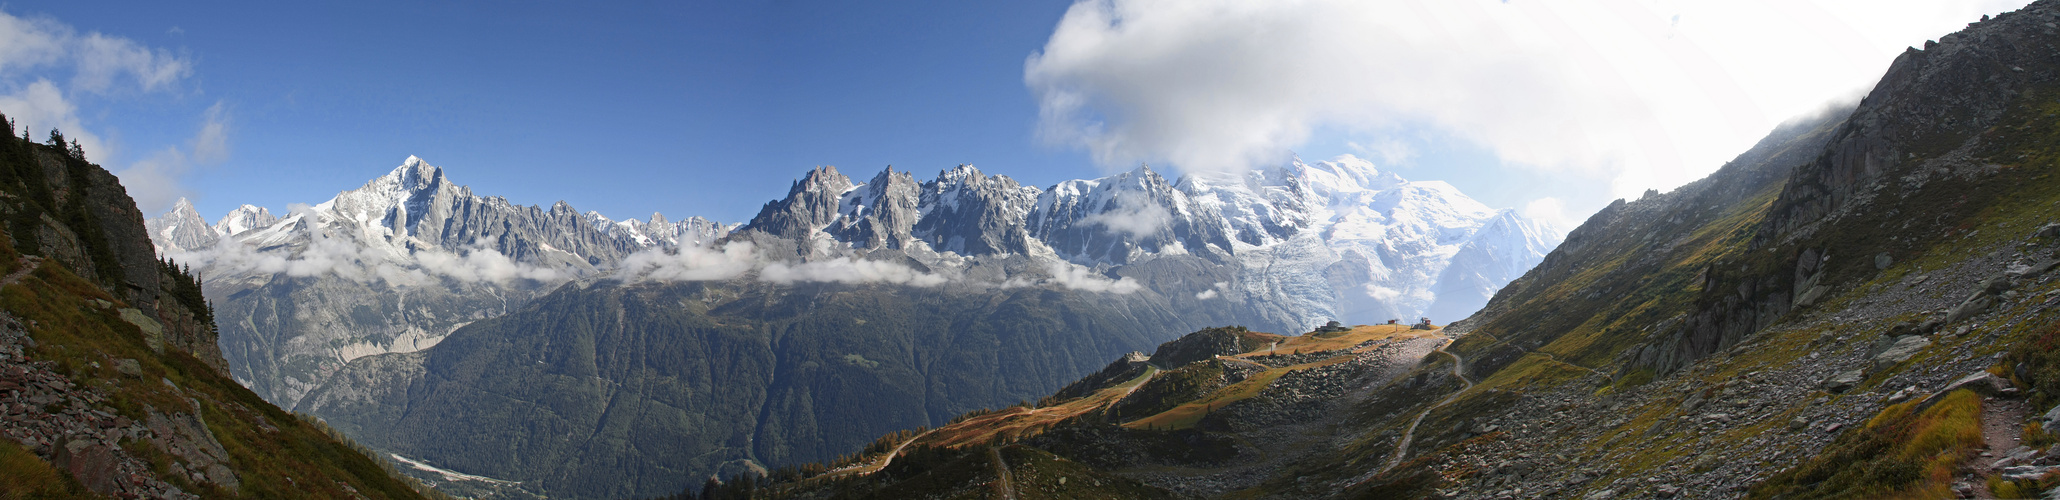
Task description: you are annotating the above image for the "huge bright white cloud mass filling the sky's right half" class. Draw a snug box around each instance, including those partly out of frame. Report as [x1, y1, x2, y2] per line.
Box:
[1024, 0, 2025, 195]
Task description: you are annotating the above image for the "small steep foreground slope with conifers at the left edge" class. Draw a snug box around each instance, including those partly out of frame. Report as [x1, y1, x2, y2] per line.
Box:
[0, 127, 420, 498]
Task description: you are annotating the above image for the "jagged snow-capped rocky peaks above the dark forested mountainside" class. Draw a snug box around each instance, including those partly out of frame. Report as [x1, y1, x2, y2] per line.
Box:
[146, 156, 1559, 403]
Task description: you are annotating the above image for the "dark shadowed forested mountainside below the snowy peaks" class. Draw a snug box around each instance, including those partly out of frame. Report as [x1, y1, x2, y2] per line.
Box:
[299, 282, 1228, 498]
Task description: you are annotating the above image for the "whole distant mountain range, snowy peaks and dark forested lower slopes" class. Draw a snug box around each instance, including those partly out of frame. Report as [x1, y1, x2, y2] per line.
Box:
[148, 156, 1559, 496]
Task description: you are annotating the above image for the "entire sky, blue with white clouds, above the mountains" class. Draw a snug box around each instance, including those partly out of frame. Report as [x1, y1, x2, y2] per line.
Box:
[0, 0, 2023, 224]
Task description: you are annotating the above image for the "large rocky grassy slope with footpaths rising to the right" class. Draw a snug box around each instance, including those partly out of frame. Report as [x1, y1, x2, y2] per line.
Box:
[684, 0, 2060, 500]
